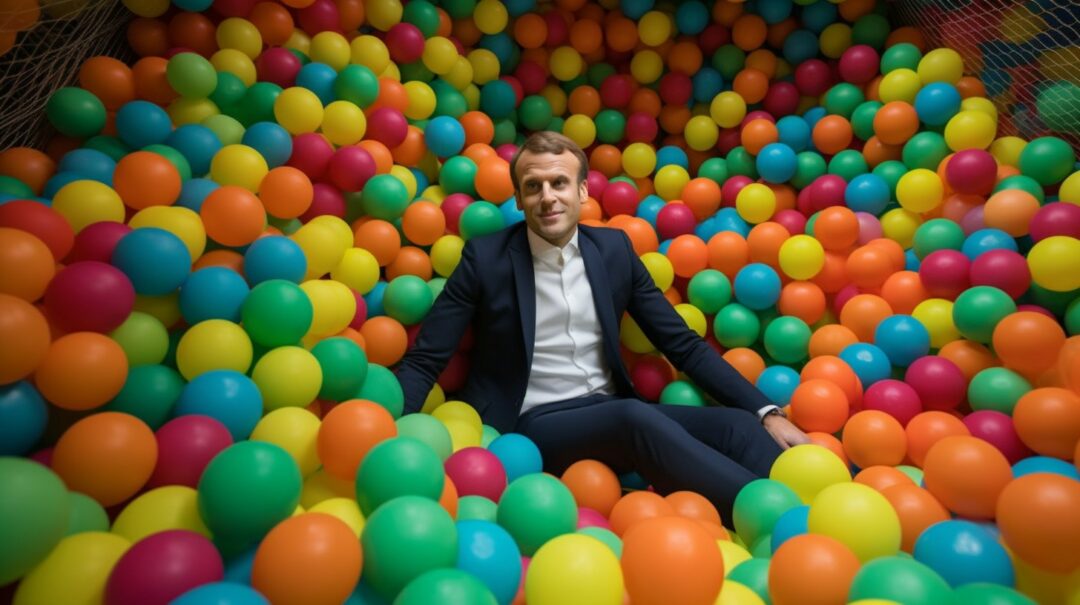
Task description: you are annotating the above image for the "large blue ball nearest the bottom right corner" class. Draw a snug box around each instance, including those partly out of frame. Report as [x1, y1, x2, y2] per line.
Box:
[912, 521, 1016, 588]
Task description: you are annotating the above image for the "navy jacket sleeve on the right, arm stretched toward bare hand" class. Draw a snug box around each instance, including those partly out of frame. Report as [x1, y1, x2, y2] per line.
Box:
[622, 229, 771, 414]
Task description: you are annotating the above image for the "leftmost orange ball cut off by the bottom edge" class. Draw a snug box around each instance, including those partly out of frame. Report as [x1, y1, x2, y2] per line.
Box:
[252, 512, 363, 605]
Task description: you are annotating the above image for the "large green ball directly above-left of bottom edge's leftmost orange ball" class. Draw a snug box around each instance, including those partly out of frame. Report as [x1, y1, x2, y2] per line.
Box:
[199, 441, 303, 547]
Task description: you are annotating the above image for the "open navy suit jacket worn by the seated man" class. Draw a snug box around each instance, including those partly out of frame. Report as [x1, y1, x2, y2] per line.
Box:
[397, 223, 770, 432]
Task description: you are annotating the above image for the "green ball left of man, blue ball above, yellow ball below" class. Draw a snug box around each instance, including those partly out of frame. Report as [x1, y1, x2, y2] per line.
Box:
[240, 280, 314, 347]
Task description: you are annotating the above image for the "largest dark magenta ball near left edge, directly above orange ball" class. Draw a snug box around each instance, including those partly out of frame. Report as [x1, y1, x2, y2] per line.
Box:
[45, 260, 135, 334]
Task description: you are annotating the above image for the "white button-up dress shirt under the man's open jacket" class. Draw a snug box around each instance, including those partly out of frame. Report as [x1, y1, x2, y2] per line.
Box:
[521, 230, 615, 414]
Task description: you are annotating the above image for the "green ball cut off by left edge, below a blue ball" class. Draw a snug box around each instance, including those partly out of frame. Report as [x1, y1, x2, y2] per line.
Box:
[0, 456, 71, 586]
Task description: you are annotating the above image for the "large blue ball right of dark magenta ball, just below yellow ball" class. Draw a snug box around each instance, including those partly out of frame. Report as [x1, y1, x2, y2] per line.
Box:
[112, 227, 191, 296]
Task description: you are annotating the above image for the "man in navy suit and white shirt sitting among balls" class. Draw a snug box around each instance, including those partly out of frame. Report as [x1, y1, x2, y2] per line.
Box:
[397, 132, 809, 522]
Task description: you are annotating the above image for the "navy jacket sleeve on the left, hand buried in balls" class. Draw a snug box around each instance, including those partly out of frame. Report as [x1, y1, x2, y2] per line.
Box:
[397, 242, 481, 414]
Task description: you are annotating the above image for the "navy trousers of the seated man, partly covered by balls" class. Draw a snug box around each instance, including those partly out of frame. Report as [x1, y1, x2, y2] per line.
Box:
[516, 395, 781, 527]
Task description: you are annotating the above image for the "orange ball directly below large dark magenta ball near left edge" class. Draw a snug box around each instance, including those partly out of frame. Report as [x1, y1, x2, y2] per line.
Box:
[35, 332, 127, 411]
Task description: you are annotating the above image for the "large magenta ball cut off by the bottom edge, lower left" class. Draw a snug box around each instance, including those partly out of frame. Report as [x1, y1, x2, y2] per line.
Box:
[105, 529, 225, 605]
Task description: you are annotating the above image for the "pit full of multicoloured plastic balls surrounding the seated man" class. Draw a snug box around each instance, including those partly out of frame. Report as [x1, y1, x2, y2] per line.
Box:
[0, 0, 1080, 605]
